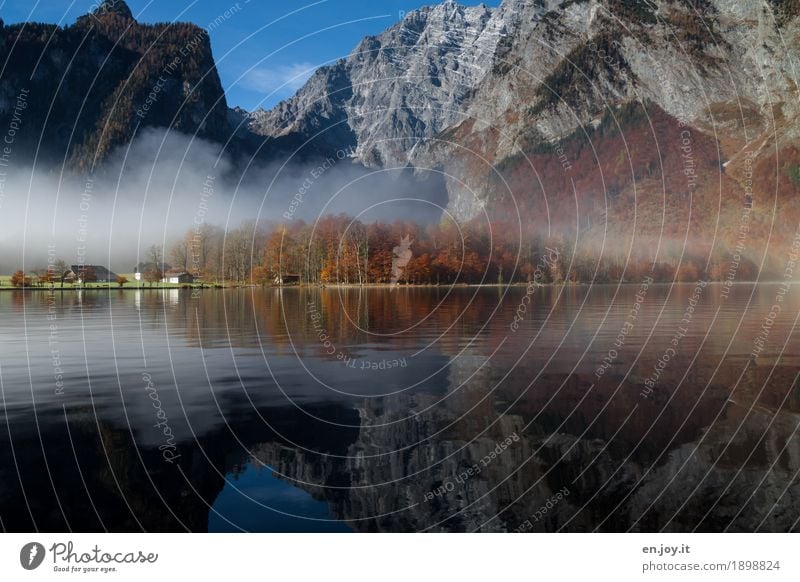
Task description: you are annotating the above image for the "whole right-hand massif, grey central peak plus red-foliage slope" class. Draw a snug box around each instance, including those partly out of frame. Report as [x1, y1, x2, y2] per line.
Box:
[250, 0, 800, 276]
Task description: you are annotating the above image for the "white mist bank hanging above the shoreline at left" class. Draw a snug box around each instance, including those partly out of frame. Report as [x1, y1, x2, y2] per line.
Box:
[0, 129, 447, 273]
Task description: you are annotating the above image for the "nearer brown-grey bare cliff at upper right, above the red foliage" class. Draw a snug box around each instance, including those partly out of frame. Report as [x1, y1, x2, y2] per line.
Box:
[439, 0, 800, 216]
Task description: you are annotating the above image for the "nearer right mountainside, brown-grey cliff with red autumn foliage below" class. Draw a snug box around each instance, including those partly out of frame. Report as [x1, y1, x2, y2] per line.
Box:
[428, 0, 800, 280]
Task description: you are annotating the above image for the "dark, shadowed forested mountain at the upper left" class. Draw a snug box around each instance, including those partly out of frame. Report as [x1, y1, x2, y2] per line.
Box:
[0, 0, 228, 171]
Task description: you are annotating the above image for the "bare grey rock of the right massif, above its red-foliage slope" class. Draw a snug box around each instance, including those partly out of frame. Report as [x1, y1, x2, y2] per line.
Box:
[249, 0, 798, 224]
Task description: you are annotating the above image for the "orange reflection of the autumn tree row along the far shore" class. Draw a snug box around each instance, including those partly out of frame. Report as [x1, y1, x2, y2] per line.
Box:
[168, 288, 495, 347]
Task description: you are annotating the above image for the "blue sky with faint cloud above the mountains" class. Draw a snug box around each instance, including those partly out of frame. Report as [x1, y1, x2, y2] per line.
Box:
[0, 0, 499, 110]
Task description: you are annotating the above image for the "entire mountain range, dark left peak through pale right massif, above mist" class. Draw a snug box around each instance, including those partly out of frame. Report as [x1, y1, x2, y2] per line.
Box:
[0, 0, 800, 277]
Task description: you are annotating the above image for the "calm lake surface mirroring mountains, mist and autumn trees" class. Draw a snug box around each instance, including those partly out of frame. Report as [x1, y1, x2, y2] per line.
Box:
[0, 282, 800, 532]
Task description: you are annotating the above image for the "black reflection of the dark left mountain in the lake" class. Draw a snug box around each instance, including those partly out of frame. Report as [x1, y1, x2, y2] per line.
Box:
[0, 407, 358, 532]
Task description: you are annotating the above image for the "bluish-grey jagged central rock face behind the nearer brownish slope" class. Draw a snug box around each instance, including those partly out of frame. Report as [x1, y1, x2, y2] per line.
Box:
[244, 0, 507, 166]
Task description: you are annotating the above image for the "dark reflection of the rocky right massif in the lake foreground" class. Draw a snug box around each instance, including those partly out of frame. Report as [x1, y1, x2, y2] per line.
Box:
[245, 368, 800, 531]
